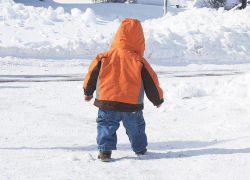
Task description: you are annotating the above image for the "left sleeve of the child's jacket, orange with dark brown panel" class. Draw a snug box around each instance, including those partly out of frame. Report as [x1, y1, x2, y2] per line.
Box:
[83, 54, 102, 96]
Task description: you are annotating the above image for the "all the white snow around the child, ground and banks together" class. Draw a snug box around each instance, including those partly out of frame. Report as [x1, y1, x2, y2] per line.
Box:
[0, 0, 250, 180]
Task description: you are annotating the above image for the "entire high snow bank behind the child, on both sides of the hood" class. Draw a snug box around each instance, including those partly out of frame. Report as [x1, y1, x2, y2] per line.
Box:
[0, 0, 250, 62]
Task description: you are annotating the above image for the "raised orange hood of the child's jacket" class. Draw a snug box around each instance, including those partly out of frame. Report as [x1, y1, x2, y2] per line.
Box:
[111, 18, 145, 56]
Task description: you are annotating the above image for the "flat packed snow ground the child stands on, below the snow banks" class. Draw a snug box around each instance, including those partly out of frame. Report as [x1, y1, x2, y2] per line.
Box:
[0, 58, 250, 180]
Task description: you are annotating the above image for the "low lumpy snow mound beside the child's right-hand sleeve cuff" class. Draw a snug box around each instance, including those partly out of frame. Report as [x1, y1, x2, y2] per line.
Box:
[162, 73, 250, 102]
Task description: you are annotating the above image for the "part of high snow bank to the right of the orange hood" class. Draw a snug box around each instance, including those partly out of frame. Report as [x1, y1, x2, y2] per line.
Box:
[143, 7, 250, 61]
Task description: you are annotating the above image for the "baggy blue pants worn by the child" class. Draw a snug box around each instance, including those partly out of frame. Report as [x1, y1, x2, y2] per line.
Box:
[96, 108, 148, 152]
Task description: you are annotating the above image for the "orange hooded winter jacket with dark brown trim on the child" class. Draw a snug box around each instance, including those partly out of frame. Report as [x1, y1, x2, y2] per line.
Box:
[83, 18, 163, 112]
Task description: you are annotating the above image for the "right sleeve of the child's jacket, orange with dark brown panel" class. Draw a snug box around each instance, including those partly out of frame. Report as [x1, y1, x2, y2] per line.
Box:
[141, 59, 164, 106]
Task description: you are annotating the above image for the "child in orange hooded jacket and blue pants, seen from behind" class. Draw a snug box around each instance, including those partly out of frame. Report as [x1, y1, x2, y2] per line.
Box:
[83, 18, 164, 162]
